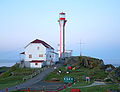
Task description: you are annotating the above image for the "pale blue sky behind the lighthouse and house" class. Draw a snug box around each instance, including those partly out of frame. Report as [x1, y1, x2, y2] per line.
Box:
[0, 0, 120, 63]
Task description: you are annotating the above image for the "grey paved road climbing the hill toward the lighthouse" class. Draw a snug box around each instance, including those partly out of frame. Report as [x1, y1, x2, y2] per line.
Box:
[0, 64, 62, 92]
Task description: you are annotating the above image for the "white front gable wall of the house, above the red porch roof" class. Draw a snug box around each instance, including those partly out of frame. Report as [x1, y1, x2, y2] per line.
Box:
[25, 43, 46, 61]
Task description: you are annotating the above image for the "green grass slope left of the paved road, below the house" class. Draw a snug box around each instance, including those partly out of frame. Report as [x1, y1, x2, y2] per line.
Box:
[0, 65, 38, 89]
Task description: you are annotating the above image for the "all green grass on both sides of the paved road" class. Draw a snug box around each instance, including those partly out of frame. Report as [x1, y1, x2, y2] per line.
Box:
[0, 57, 112, 92]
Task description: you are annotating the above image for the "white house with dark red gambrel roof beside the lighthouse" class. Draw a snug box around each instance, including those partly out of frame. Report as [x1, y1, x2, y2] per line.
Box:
[21, 39, 59, 68]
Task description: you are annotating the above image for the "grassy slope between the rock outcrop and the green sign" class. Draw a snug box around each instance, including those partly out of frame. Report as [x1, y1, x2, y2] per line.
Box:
[44, 66, 107, 84]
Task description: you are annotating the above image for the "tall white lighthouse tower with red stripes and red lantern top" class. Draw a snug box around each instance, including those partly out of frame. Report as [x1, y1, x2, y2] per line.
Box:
[58, 12, 67, 58]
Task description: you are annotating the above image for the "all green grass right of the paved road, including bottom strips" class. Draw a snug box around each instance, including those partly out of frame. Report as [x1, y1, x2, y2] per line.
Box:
[44, 66, 109, 92]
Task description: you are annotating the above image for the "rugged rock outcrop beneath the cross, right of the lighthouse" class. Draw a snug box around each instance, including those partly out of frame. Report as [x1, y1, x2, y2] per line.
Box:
[64, 56, 104, 68]
